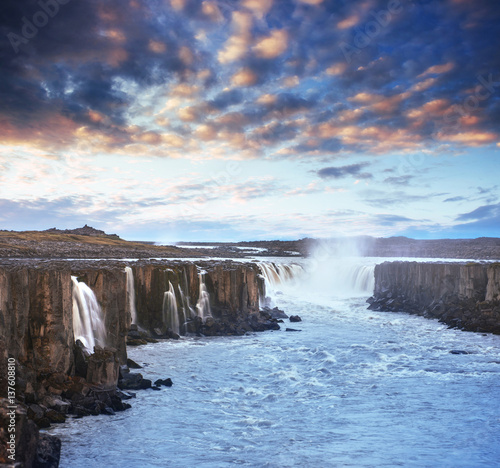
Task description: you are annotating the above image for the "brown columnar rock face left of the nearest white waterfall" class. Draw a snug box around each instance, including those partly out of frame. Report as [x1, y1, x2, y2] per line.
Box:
[0, 267, 73, 404]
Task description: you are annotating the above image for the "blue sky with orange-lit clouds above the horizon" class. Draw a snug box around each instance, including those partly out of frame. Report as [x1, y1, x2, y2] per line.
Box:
[0, 0, 500, 242]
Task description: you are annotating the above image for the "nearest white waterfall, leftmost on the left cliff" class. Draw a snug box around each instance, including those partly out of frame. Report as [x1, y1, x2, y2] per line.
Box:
[71, 276, 106, 353]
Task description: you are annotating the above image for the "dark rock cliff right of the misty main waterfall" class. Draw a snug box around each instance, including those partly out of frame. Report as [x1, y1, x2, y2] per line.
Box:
[368, 262, 500, 334]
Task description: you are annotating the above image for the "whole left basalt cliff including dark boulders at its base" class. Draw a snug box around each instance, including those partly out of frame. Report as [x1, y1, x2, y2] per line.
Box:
[0, 260, 279, 466]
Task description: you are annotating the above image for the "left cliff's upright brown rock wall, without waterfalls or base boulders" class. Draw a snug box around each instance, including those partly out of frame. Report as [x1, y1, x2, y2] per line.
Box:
[0, 261, 270, 399]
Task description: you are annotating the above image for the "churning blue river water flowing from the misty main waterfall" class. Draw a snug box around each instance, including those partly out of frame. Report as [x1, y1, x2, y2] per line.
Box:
[49, 258, 500, 468]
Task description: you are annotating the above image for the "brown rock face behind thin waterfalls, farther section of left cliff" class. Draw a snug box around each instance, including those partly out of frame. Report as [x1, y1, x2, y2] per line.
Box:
[132, 261, 275, 337]
